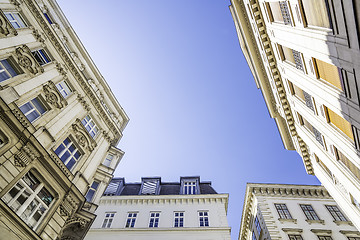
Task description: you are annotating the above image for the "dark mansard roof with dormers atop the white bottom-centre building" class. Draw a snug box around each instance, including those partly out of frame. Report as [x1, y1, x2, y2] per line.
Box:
[104, 176, 217, 196]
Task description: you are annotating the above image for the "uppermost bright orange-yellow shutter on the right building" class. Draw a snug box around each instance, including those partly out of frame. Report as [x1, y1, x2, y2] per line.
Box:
[314, 59, 342, 90]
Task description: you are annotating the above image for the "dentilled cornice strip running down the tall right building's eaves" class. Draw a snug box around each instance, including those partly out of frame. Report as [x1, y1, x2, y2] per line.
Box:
[231, 0, 314, 175]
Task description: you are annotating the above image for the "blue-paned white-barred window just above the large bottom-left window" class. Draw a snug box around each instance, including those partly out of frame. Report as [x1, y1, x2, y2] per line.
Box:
[55, 137, 81, 170]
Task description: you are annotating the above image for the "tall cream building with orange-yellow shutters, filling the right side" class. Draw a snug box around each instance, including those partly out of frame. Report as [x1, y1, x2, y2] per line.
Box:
[230, 0, 360, 229]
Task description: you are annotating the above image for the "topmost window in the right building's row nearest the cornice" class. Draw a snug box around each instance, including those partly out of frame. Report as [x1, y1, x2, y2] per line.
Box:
[266, 1, 291, 25]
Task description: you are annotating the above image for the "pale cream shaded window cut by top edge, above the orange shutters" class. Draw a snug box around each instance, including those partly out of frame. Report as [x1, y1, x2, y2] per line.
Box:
[301, 0, 331, 28]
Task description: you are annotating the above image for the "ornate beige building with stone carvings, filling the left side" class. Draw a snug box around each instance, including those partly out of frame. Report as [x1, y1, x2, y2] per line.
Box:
[0, 0, 129, 240]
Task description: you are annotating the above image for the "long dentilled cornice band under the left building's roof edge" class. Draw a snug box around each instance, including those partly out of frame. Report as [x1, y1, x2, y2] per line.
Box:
[24, 0, 122, 143]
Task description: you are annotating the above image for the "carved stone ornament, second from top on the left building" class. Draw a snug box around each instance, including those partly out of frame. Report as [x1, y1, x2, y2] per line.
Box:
[15, 45, 44, 75]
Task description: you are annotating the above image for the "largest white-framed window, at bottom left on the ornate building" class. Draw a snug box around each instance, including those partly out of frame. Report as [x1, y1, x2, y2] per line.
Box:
[1, 172, 54, 229]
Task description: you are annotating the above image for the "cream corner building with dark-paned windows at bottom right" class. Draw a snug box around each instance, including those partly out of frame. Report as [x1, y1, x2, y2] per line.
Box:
[239, 183, 360, 240]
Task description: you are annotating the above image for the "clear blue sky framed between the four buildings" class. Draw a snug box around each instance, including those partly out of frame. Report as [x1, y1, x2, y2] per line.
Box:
[58, 0, 319, 239]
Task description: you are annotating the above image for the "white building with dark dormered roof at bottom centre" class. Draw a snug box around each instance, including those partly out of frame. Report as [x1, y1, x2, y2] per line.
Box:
[85, 177, 230, 240]
